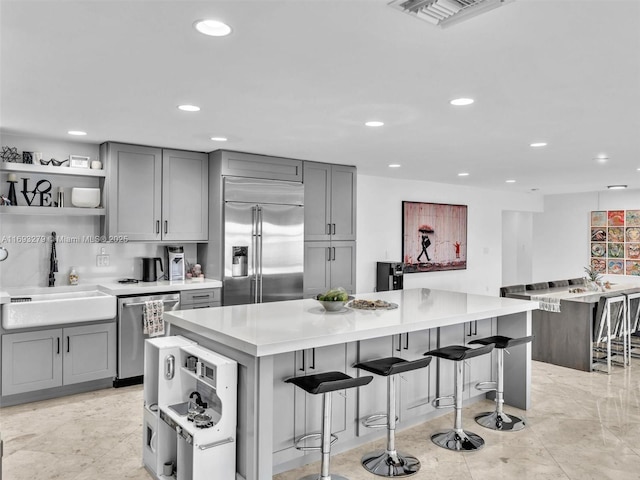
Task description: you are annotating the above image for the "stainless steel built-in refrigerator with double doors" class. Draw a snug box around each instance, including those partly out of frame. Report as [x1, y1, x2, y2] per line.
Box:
[222, 177, 304, 305]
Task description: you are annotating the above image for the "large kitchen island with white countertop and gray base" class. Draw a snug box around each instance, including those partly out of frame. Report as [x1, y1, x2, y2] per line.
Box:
[165, 288, 538, 480]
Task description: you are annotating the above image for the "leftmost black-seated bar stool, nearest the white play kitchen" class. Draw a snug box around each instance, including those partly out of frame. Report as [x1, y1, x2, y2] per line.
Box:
[285, 372, 373, 480]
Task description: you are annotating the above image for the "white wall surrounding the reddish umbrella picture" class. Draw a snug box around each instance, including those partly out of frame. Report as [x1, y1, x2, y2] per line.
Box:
[356, 175, 542, 295]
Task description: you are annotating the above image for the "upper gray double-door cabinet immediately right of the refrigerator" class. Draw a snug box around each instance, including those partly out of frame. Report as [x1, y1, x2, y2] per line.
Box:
[304, 162, 356, 241]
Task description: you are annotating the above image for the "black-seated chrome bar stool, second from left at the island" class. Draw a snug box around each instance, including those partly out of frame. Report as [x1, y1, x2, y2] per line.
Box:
[354, 357, 431, 477]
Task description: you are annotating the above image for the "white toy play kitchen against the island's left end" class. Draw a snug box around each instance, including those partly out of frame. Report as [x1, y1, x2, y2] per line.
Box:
[143, 336, 238, 480]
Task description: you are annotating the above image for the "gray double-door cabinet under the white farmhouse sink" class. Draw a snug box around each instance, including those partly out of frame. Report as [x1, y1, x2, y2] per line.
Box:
[2, 322, 116, 396]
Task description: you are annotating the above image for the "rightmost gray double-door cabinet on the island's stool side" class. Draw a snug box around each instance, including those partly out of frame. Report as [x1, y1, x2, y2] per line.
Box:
[433, 319, 496, 400]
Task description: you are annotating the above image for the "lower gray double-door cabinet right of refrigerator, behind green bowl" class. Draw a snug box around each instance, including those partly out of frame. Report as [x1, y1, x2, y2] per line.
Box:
[304, 241, 356, 298]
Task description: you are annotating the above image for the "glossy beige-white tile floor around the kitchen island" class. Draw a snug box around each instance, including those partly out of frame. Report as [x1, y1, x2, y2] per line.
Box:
[0, 360, 640, 480]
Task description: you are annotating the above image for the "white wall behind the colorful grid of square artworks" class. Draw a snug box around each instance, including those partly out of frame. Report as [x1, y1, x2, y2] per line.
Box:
[532, 190, 640, 283]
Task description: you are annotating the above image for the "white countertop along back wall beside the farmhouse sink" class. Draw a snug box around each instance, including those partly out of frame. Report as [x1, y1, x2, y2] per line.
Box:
[0, 278, 222, 304]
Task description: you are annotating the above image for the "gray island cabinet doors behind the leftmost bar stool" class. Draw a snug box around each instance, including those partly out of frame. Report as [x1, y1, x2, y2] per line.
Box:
[273, 344, 355, 464]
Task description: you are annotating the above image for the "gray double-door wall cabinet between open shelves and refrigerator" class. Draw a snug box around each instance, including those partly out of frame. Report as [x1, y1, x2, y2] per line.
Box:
[100, 143, 209, 242]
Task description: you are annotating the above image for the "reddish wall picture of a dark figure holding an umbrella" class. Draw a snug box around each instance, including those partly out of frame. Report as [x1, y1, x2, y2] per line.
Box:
[402, 201, 467, 273]
